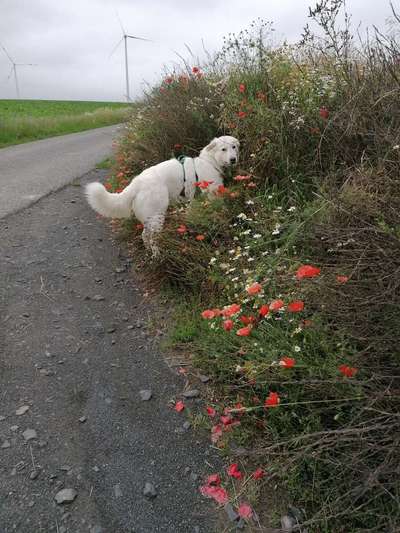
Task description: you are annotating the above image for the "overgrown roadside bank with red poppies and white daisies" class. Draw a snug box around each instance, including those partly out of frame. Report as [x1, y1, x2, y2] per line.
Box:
[107, 0, 400, 533]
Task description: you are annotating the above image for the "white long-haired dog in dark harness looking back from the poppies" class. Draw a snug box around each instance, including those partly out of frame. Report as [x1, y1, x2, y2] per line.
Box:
[86, 135, 239, 255]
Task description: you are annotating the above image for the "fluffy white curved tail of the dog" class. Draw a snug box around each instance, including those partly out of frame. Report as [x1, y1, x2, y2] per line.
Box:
[85, 182, 135, 218]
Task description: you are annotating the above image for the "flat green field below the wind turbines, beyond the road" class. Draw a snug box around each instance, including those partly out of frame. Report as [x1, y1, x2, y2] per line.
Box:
[0, 100, 132, 147]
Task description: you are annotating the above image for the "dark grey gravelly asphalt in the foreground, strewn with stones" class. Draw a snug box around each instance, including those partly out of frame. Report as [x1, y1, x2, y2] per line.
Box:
[0, 135, 220, 533]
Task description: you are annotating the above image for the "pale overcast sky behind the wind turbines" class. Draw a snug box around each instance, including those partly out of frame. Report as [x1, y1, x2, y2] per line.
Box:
[0, 0, 400, 101]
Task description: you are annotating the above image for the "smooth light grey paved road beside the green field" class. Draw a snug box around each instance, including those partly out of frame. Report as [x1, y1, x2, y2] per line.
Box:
[0, 126, 120, 218]
